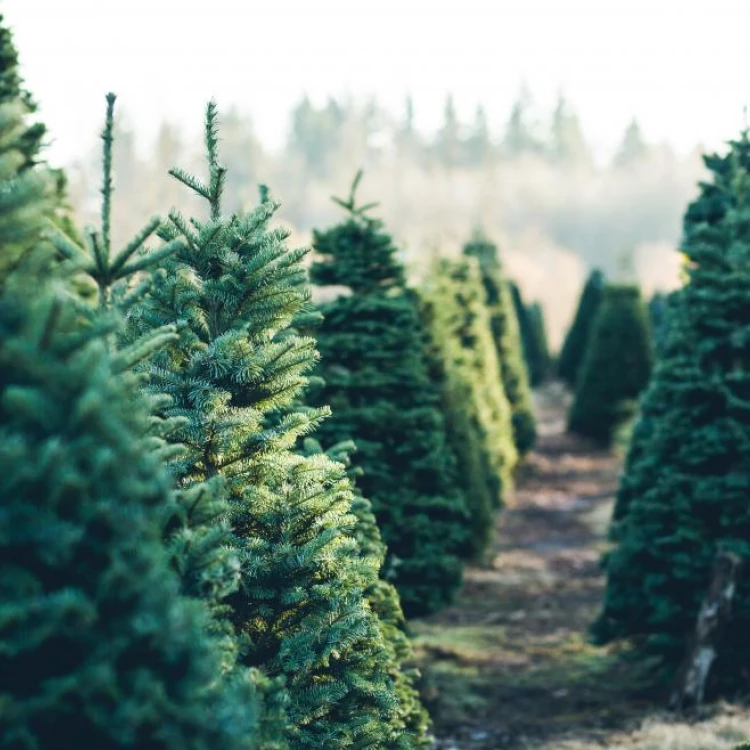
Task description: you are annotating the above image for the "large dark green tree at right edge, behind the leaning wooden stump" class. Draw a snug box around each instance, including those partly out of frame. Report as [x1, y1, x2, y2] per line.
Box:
[594, 132, 750, 692]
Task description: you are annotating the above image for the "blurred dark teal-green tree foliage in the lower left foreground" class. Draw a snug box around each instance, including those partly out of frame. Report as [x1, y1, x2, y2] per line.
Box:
[0, 288, 272, 750]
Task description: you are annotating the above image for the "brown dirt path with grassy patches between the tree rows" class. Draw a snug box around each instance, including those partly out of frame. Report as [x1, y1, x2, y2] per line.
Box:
[413, 384, 646, 750]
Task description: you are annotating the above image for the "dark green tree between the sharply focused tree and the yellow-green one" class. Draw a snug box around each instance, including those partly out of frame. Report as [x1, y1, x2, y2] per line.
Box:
[311, 176, 468, 614]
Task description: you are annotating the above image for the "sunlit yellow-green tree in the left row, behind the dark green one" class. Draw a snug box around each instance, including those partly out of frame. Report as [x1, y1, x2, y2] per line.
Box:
[422, 258, 518, 559]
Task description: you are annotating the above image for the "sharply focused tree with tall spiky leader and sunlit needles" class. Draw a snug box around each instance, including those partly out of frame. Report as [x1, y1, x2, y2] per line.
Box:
[136, 111, 428, 750]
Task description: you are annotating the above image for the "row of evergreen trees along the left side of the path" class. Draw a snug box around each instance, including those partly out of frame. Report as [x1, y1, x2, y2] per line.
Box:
[0, 13, 546, 750]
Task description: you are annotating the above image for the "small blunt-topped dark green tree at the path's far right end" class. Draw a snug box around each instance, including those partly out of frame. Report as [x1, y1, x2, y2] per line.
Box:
[568, 285, 653, 445]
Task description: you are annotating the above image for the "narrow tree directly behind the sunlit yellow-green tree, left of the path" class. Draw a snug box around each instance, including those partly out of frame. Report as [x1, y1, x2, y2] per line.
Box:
[464, 233, 536, 456]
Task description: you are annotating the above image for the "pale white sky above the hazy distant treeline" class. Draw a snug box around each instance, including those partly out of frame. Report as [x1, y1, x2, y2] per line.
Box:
[5, 0, 750, 162]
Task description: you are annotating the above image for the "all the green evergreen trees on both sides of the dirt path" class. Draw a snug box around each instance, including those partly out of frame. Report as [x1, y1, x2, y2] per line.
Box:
[0, 11, 750, 750]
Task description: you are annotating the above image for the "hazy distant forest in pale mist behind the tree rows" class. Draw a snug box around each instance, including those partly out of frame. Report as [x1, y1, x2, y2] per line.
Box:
[63, 94, 702, 346]
